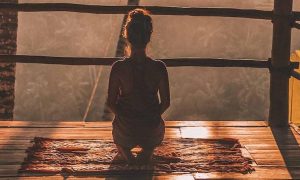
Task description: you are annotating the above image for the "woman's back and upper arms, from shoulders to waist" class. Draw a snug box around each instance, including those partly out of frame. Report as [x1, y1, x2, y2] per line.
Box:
[109, 58, 169, 118]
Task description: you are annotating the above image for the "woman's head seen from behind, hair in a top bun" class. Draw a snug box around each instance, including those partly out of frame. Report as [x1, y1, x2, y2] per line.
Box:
[123, 8, 153, 49]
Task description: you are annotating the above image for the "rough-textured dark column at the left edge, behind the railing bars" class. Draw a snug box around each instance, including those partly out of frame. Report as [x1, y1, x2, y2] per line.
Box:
[0, 0, 18, 120]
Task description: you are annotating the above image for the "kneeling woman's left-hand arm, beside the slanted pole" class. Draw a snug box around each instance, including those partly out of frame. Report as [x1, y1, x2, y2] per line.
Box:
[107, 62, 120, 115]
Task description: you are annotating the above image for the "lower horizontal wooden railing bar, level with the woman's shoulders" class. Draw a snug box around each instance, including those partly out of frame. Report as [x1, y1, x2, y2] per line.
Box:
[0, 55, 270, 68]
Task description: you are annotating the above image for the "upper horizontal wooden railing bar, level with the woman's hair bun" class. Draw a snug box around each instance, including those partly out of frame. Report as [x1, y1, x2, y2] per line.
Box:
[0, 3, 272, 19]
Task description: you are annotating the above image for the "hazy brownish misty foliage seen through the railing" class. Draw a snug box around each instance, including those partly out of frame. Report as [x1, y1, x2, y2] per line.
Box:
[14, 0, 300, 121]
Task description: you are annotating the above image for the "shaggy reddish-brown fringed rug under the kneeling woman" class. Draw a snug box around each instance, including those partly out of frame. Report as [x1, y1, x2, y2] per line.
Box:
[19, 137, 254, 175]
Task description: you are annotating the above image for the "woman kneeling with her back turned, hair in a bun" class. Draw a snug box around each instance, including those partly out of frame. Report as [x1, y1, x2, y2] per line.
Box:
[108, 9, 170, 163]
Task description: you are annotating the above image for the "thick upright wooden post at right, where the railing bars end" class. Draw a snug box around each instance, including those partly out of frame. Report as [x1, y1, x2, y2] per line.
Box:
[269, 0, 293, 126]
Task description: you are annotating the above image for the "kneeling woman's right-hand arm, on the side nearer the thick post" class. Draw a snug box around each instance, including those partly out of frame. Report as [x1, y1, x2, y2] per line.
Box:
[158, 63, 170, 114]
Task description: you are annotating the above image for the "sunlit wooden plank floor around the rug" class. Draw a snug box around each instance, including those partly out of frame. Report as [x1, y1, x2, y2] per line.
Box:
[0, 121, 300, 180]
